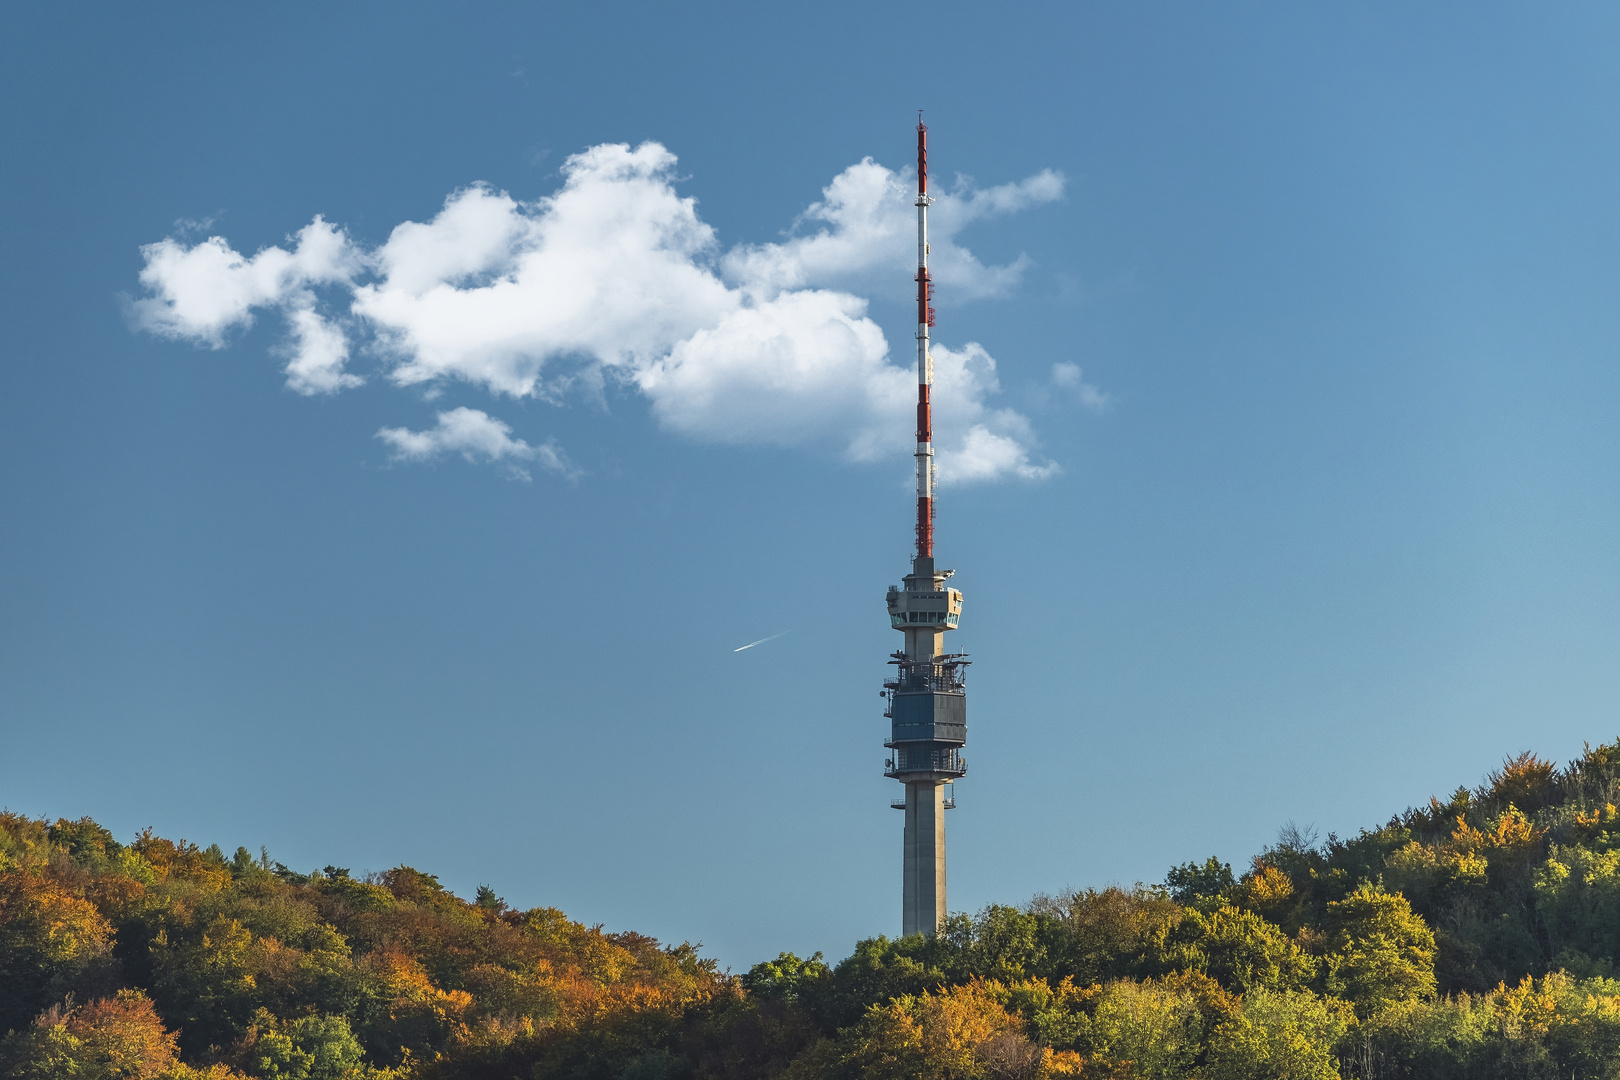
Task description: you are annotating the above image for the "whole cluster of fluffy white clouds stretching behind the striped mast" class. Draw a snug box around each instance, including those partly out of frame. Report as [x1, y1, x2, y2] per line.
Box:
[131, 142, 1100, 483]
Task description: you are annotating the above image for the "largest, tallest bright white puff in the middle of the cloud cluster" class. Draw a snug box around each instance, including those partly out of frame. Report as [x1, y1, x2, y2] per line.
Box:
[355, 142, 740, 397]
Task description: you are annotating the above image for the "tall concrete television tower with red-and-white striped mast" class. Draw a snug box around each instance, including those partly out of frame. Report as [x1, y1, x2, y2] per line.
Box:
[883, 113, 969, 934]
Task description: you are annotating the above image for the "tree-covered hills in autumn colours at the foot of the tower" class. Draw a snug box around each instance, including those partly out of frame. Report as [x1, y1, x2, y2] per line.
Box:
[9, 743, 1620, 1080]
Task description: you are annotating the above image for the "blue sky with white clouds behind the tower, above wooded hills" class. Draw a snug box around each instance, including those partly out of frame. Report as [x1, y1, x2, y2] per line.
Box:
[0, 3, 1620, 968]
